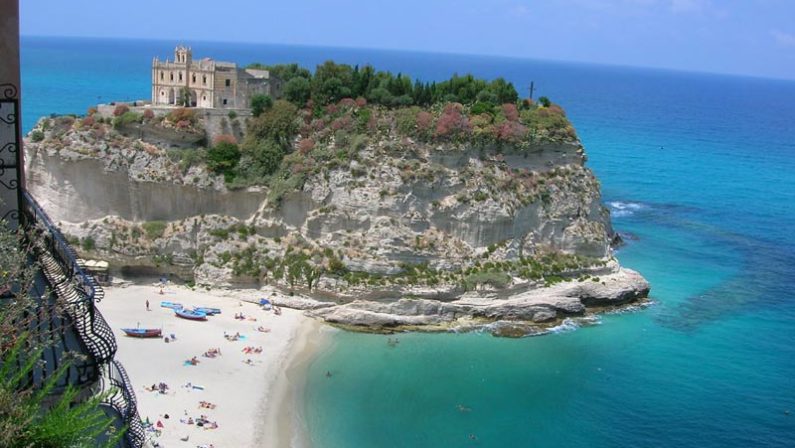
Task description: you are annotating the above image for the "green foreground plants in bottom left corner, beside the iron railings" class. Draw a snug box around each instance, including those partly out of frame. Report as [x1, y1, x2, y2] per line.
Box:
[0, 220, 124, 448]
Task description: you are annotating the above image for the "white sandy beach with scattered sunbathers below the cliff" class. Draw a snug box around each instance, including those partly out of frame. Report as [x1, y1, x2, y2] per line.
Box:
[98, 285, 321, 448]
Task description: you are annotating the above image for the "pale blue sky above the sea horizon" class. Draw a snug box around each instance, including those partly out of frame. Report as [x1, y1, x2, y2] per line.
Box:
[20, 0, 795, 79]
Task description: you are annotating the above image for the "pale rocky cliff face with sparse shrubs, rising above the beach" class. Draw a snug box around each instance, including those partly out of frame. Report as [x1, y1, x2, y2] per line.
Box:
[26, 101, 649, 327]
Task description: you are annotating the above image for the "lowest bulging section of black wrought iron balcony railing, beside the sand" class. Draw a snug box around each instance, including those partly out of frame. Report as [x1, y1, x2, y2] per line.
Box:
[102, 361, 146, 448]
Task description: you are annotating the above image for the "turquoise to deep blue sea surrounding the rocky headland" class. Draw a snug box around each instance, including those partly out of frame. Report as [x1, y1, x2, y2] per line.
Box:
[22, 37, 795, 448]
